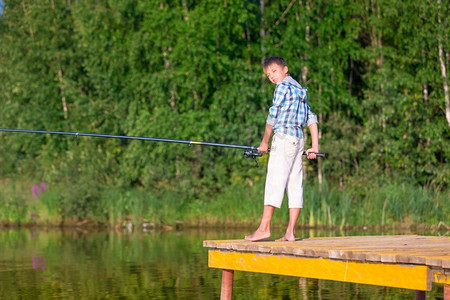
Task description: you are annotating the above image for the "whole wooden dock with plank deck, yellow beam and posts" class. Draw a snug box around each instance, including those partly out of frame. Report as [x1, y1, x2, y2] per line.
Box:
[203, 235, 450, 300]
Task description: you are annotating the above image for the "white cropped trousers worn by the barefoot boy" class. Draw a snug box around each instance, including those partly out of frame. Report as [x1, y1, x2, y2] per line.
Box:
[264, 133, 304, 208]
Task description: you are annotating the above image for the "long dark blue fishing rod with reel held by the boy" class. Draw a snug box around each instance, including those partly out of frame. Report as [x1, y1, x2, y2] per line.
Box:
[0, 128, 325, 167]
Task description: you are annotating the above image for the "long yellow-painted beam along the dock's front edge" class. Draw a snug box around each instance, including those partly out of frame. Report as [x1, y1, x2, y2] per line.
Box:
[208, 249, 432, 291]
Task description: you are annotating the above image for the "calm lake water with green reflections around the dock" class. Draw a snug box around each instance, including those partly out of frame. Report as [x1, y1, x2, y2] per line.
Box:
[0, 229, 443, 300]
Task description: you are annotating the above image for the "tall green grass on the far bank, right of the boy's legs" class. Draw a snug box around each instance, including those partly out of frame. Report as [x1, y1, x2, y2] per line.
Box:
[300, 182, 450, 228]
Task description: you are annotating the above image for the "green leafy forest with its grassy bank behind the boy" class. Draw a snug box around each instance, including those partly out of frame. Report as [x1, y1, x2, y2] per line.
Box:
[0, 0, 450, 228]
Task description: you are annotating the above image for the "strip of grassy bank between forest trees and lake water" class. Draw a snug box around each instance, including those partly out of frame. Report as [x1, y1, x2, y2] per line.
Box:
[0, 179, 450, 228]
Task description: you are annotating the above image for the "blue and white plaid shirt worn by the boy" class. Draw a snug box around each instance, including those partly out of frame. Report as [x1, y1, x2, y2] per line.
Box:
[266, 76, 318, 138]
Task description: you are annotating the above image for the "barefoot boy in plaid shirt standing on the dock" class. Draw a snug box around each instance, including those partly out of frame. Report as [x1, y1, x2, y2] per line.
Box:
[245, 56, 319, 242]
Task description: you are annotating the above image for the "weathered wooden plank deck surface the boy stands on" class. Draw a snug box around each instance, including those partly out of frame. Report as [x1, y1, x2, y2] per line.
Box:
[204, 235, 450, 268]
